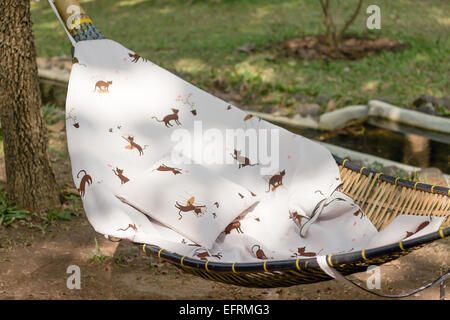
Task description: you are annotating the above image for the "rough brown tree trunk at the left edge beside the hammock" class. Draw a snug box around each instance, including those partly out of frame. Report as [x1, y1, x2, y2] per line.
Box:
[0, 0, 60, 211]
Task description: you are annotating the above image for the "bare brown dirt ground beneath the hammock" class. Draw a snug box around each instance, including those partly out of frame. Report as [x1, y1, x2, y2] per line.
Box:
[0, 125, 450, 300]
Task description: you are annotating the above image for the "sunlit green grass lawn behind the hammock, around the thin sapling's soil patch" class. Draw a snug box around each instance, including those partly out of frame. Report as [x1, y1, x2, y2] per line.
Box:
[32, 0, 450, 107]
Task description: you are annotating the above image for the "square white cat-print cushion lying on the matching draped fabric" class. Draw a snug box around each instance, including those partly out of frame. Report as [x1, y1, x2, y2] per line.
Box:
[115, 158, 258, 249]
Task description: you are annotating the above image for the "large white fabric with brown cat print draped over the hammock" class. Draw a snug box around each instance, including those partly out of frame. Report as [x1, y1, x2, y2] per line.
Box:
[66, 39, 444, 262]
